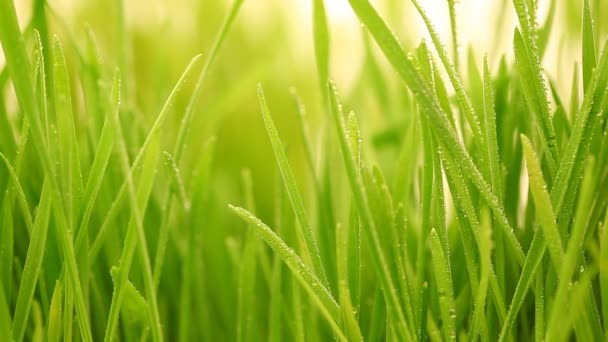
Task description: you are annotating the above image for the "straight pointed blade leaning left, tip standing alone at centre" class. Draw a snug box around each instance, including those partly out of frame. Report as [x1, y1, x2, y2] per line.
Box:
[258, 84, 328, 286]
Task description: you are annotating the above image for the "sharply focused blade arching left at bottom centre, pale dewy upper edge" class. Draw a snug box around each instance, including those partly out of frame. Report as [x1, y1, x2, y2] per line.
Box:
[229, 205, 346, 340]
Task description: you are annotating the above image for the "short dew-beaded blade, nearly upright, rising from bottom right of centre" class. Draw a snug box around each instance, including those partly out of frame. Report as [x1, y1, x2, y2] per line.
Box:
[431, 229, 456, 341]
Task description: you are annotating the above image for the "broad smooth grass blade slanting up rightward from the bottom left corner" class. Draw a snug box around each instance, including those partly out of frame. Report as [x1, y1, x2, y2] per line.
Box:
[13, 182, 51, 342]
